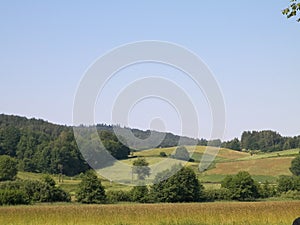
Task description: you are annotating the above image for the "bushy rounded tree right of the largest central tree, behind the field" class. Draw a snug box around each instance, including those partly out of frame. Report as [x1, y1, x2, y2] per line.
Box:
[222, 171, 259, 201]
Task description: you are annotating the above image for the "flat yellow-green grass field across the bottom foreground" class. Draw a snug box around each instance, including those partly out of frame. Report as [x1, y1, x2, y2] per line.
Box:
[0, 201, 300, 225]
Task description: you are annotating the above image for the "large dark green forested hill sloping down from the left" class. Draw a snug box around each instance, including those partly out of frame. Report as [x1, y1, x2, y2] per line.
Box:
[0, 114, 202, 176]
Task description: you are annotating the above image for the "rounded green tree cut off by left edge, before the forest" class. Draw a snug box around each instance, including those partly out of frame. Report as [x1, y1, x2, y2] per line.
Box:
[0, 155, 18, 181]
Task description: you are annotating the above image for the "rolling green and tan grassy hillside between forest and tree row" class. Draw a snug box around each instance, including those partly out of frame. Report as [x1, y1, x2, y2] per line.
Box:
[18, 146, 299, 192]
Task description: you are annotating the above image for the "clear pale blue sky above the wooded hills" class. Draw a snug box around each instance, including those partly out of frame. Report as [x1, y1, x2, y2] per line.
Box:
[0, 0, 300, 139]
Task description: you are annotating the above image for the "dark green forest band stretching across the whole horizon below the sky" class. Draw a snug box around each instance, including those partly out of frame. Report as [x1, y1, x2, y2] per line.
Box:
[0, 114, 300, 176]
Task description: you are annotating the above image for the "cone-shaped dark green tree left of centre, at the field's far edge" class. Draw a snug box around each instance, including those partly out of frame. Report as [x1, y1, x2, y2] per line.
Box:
[76, 170, 106, 204]
